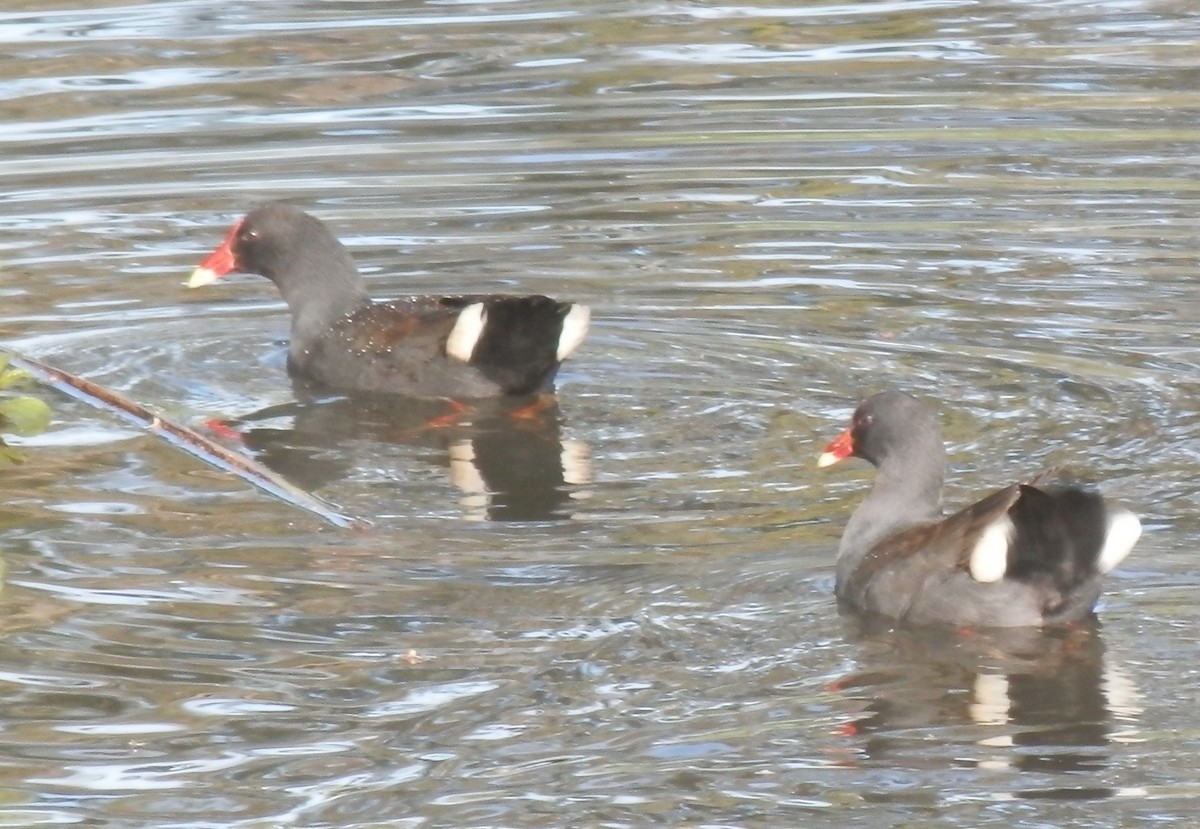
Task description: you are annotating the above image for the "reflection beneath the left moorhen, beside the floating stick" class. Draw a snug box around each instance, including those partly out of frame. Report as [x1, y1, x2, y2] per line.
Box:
[219, 395, 590, 521]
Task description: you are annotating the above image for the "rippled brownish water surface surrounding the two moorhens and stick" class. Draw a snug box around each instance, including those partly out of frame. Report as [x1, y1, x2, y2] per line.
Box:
[0, 0, 1200, 828]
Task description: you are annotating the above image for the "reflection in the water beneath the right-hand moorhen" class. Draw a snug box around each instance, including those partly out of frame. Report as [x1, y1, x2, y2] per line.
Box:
[833, 617, 1136, 798]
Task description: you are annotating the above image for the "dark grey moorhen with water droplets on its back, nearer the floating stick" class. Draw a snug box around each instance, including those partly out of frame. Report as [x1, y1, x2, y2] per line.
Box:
[187, 204, 589, 397]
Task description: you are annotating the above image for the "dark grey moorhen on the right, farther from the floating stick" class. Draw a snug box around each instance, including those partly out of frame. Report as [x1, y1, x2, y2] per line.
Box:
[817, 391, 1141, 627]
